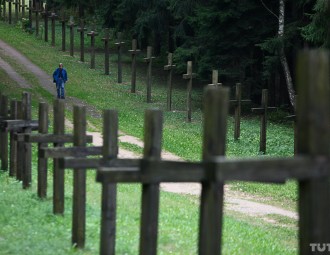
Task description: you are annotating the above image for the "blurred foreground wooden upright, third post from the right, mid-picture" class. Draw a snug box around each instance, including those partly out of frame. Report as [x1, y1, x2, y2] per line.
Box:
[140, 110, 163, 255]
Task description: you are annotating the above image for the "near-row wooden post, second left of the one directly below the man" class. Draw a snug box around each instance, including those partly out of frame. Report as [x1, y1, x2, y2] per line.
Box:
[22, 92, 32, 189]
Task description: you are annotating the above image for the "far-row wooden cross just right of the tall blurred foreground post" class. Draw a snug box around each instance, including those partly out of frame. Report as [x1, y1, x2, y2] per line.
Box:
[229, 83, 251, 140]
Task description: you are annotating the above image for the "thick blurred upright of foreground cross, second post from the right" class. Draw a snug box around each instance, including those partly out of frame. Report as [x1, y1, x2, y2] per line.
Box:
[198, 88, 229, 254]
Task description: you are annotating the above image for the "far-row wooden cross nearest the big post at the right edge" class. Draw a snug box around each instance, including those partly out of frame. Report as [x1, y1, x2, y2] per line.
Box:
[252, 89, 277, 154]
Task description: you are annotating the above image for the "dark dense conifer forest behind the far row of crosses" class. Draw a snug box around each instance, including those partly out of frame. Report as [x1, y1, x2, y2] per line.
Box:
[40, 0, 330, 109]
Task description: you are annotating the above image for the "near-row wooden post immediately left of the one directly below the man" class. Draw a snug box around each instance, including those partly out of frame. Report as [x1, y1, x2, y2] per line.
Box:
[37, 103, 48, 198]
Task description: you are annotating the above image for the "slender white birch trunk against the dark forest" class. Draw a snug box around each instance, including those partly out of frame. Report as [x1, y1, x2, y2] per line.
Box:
[278, 0, 296, 109]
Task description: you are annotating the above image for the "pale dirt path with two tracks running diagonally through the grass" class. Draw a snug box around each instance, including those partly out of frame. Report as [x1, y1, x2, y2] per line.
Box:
[0, 40, 298, 222]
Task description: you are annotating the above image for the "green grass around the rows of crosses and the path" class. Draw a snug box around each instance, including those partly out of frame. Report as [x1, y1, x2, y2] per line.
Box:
[0, 20, 297, 254]
